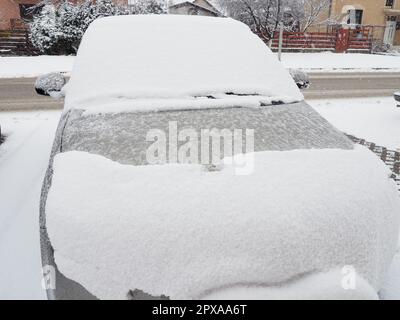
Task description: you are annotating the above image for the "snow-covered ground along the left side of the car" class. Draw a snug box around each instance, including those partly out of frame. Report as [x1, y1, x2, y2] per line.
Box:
[0, 111, 60, 299]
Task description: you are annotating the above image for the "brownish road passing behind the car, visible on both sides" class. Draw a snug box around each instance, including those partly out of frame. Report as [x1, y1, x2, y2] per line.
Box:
[0, 72, 400, 111]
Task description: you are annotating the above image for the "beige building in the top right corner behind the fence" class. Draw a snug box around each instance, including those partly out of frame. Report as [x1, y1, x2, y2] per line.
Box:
[329, 0, 400, 45]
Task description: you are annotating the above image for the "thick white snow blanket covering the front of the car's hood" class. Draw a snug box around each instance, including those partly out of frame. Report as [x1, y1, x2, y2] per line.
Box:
[46, 146, 400, 299]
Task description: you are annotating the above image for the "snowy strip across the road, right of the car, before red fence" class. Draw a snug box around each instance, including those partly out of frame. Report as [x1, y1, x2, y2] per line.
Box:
[282, 52, 400, 72]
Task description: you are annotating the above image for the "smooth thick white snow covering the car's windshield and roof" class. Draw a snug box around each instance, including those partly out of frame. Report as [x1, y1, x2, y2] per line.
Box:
[65, 15, 303, 109]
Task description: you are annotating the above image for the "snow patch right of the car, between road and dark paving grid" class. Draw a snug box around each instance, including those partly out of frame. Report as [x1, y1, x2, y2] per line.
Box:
[308, 97, 400, 150]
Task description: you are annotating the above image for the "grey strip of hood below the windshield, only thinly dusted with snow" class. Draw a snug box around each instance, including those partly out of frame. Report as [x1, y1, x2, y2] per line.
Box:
[62, 102, 353, 165]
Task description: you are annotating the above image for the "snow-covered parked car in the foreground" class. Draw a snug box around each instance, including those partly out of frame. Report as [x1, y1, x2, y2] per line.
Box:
[40, 15, 400, 299]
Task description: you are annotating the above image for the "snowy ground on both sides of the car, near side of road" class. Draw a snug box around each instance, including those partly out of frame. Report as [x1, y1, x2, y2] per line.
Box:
[0, 98, 400, 299]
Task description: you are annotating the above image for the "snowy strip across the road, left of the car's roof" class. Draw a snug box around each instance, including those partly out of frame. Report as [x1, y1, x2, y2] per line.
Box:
[0, 56, 75, 78]
